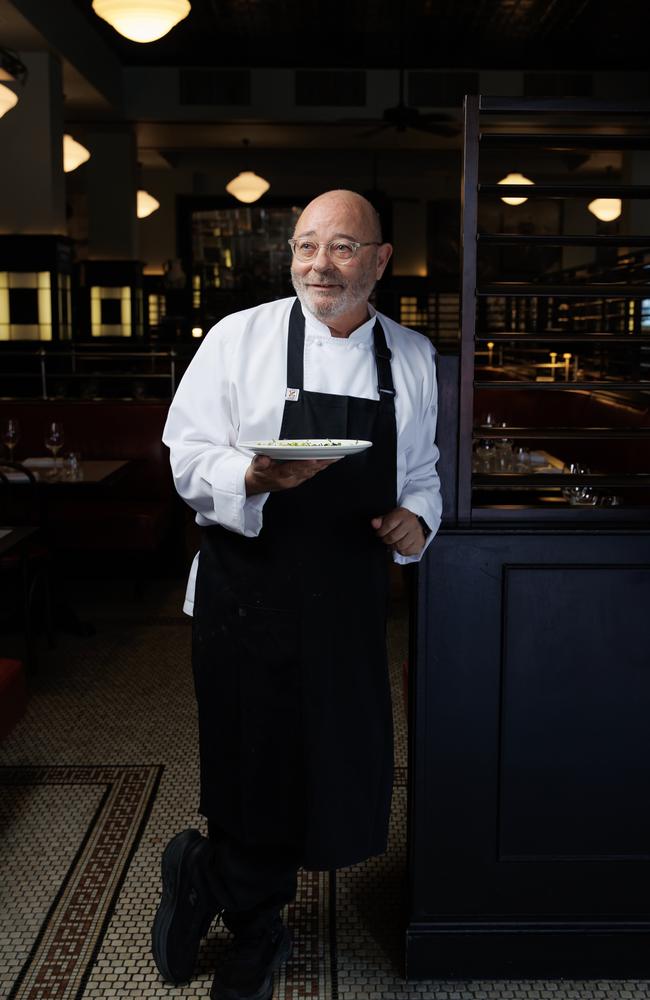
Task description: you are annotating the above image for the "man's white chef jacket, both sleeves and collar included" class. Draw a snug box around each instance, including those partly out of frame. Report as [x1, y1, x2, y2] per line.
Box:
[163, 298, 442, 615]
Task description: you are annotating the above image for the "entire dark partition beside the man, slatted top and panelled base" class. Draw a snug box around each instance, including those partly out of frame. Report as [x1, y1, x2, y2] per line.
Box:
[406, 98, 650, 978]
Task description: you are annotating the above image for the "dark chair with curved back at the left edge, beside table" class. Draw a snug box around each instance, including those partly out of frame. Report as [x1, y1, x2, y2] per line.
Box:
[0, 461, 54, 669]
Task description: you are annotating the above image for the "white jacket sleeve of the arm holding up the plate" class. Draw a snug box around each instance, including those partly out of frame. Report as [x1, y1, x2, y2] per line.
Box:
[163, 315, 269, 537]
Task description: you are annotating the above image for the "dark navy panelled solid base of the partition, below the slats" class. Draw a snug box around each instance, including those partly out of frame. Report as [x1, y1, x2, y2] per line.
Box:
[407, 528, 650, 978]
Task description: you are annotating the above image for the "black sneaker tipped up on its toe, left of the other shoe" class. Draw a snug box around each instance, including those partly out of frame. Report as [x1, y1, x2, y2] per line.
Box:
[151, 830, 223, 983]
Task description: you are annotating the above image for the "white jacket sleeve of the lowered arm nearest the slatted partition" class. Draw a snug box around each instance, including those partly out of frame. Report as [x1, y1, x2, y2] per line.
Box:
[393, 342, 442, 565]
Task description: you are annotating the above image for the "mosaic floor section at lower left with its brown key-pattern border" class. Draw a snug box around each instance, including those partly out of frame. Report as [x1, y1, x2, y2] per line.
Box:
[0, 766, 162, 1000]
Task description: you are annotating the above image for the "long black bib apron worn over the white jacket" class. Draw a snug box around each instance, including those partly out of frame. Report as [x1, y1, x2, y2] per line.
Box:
[192, 301, 397, 869]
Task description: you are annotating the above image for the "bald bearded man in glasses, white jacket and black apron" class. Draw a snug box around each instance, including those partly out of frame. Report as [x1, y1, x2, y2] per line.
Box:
[152, 191, 440, 1000]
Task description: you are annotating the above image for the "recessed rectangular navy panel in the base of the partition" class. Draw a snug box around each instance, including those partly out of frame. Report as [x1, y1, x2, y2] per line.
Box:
[498, 565, 650, 861]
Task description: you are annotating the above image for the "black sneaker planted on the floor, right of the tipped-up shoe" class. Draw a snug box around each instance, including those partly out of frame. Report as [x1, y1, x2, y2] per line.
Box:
[210, 916, 291, 1000]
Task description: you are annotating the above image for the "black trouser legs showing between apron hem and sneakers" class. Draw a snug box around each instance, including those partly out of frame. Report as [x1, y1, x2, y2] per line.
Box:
[205, 820, 300, 933]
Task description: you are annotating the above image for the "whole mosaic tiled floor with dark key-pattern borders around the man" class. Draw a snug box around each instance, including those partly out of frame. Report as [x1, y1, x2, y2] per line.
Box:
[0, 582, 650, 1000]
